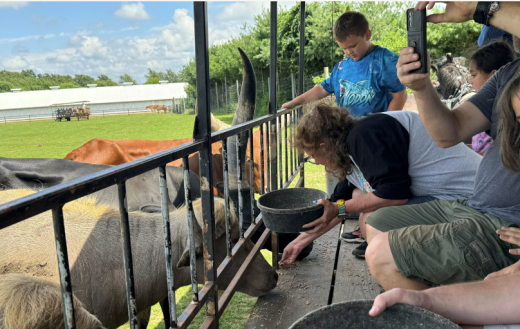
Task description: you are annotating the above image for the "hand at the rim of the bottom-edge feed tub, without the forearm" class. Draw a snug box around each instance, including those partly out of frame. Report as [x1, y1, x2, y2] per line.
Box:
[368, 288, 432, 316]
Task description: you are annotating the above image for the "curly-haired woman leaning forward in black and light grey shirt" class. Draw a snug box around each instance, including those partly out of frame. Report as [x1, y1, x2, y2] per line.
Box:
[281, 104, 482, 265]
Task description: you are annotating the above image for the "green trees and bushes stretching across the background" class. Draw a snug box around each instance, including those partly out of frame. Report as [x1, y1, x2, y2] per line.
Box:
[0, 1, 480, 93]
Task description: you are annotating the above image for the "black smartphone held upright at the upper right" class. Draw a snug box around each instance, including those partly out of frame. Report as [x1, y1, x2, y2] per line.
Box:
[406, 8, 428, 73]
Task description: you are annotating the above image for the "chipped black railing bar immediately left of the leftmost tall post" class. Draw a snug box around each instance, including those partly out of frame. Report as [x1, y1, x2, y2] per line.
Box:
[183, 157, 199, 302]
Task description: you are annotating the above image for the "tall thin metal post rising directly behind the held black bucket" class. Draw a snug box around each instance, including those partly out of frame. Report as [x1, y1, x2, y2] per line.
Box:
[269, 1, 278, 269]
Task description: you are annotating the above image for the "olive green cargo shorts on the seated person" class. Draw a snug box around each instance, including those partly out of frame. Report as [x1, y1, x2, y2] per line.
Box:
[367, 200, 520, 285]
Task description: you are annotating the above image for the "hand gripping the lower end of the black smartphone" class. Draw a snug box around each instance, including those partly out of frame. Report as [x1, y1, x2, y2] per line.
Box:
[396, 47, 431, 91]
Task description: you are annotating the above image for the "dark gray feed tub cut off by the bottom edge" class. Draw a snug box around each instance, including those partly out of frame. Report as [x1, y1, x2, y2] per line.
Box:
[289, 300, 460, 329]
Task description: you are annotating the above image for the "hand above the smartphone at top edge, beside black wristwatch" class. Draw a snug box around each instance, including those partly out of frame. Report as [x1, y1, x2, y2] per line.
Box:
[415, 1, 477, 24]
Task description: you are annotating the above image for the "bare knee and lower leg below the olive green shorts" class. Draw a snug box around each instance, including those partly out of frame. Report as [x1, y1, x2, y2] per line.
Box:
[365, 231, 430, 291]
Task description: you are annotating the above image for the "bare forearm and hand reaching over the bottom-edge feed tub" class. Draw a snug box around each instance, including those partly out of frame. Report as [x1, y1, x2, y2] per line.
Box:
[369, 273, 520, 325]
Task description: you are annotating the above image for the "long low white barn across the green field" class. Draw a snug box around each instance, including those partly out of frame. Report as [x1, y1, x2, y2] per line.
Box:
[0, 82, 188, 120]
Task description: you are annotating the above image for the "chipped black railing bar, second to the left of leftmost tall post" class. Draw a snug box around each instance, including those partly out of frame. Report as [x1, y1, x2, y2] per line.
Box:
[159, 166, 177, 328]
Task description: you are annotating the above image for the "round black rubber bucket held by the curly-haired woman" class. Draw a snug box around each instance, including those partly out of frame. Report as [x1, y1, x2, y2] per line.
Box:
[257, 187, 328, 233]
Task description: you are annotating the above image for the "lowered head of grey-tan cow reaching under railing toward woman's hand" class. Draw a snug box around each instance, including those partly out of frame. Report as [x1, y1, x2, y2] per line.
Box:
[177, 198, 278, 297]
